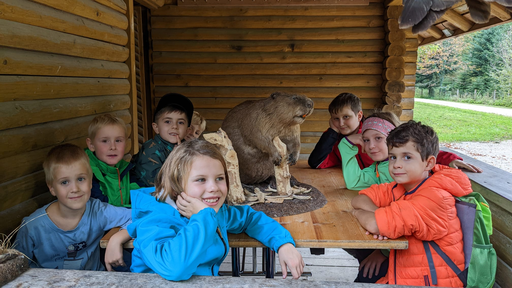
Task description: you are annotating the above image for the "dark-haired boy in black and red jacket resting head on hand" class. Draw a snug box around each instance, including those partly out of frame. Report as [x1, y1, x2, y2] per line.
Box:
[308, 93, 373, 169]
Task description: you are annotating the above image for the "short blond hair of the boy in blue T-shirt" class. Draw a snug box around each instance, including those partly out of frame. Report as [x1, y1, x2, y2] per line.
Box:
[43, 144, 92, 185]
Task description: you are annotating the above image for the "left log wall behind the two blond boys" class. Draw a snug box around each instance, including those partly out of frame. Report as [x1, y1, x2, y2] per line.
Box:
[0, 0, 137, 233]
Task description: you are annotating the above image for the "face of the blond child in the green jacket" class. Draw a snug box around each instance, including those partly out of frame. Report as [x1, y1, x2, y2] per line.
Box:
[87, 125, 126, 166]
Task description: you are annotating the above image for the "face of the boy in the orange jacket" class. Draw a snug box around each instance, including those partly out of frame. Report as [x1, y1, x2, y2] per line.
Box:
[389, 141, 436, 191]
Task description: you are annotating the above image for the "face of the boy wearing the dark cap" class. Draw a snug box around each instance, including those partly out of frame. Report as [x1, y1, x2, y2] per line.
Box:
[153, 111, 188, 144]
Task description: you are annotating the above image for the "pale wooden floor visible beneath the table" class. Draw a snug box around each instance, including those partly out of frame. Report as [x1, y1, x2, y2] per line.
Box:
[220, 248, 359, 282]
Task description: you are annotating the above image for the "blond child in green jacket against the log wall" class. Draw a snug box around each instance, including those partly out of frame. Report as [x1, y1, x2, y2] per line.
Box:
[85, 114, 140, 207]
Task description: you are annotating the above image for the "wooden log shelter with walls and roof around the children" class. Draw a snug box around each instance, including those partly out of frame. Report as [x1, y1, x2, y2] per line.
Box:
[0, 0, 512, 286]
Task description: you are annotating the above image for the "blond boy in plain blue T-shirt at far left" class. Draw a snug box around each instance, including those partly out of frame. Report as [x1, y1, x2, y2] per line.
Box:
[15, 144, 131, 271]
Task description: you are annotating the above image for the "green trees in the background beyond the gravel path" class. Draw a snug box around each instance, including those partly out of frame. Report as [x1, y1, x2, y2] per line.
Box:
[416, 23, 512, 99]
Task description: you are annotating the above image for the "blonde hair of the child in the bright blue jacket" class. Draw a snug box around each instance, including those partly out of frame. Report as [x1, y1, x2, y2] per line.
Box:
[153, 139, 229, 201]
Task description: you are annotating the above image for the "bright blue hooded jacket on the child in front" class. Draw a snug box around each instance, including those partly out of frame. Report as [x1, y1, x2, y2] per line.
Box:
[128, 187, 295, 281]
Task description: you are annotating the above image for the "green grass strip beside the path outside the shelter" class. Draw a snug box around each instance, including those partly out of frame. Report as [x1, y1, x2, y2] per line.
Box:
[414, 102, 512, 143]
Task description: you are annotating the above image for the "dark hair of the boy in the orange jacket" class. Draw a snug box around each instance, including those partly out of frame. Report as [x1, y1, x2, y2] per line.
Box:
[386, 120, 439, 161]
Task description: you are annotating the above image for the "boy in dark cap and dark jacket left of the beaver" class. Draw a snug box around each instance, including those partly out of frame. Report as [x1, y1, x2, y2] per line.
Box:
[132, 93, 194, 187]
